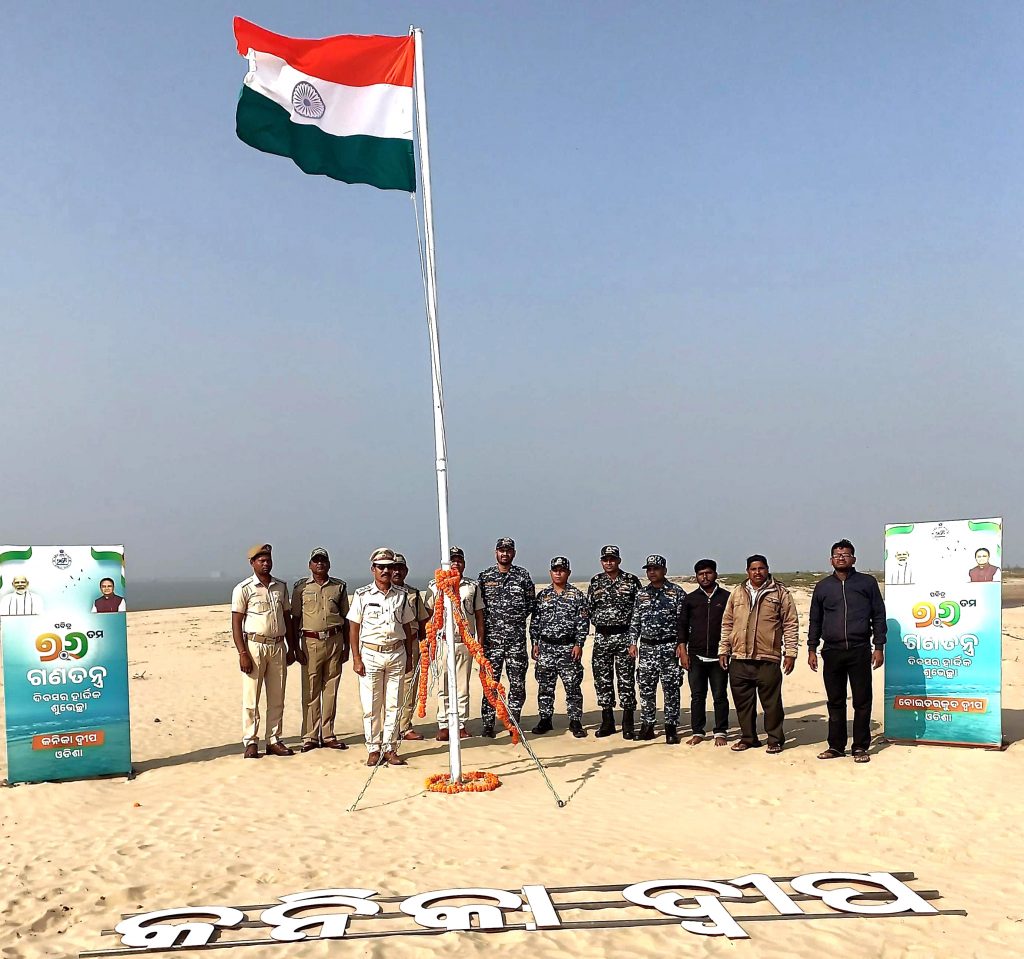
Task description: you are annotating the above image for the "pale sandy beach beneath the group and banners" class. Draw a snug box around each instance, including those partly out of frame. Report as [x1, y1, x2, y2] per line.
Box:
[0, 590, 1024, 959]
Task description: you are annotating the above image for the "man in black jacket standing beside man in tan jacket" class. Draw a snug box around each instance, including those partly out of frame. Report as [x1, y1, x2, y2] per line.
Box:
[679, 560, 729, 746]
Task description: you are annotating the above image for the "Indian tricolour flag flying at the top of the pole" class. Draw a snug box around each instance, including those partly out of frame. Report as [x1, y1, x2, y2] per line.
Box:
[234, 16, 416, 192]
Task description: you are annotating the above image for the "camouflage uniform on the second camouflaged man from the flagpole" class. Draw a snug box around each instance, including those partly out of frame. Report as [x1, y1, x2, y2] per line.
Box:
[529, 584, 590, 723]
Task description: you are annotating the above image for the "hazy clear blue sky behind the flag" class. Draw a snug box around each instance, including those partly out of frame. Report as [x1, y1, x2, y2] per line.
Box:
[0, 0, 1024, 579]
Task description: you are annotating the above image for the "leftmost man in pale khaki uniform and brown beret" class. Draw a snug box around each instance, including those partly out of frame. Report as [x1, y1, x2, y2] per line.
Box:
[231, 542, 305, 759]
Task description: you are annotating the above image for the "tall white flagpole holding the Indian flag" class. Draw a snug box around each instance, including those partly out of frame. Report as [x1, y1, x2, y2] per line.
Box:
[412, 27, 462, 782]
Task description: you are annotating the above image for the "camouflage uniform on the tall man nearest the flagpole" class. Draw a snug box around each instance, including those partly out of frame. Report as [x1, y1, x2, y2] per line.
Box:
[478, 564, 537, 728]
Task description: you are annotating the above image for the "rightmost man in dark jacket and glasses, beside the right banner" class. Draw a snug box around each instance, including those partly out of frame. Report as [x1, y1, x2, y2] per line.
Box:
[807, 539, 886, 762]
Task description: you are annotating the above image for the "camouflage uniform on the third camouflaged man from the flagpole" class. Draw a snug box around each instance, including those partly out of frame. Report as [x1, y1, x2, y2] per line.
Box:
[587, 570, 640, 710]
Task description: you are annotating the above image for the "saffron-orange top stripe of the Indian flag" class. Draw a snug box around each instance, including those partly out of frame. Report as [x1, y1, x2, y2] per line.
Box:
[234, 16, 416, 87]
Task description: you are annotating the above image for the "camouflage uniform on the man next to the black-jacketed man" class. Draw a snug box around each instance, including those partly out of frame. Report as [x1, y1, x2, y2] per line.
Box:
[630, 580, 686, 726]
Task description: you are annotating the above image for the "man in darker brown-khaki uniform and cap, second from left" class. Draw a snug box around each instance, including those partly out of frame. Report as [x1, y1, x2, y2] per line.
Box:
[292, 547, 348, 752]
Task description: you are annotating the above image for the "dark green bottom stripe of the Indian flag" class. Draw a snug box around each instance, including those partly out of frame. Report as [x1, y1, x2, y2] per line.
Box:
[234, 86, 416, 193]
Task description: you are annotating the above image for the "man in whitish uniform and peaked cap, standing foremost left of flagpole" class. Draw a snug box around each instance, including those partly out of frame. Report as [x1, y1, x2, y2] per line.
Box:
[346, 548, 416, 766]
